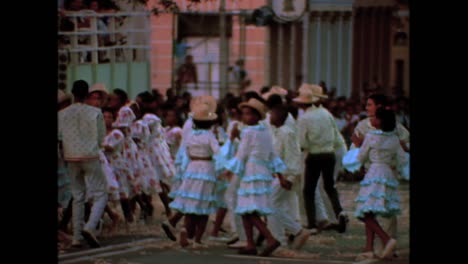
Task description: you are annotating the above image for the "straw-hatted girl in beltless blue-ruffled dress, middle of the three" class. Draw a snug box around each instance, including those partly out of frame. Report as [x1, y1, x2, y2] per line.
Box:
[225, 98, 286, 256]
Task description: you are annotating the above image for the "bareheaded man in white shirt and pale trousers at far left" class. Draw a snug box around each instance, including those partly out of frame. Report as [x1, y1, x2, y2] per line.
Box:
[58, 80, 107, 247]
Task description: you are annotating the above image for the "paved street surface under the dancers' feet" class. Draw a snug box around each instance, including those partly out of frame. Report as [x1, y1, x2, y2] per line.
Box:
[59, 182, 410, 264]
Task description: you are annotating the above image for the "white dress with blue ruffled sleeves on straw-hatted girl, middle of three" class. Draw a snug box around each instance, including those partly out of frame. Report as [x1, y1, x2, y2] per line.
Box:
[225, 123, 286, 215]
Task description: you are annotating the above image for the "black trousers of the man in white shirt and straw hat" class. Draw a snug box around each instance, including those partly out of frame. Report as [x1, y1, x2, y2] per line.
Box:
[303, 153, 343, 228]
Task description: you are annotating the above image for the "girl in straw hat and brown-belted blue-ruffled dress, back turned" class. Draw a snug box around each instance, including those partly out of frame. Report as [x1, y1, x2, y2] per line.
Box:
[170, 99, 219, 247]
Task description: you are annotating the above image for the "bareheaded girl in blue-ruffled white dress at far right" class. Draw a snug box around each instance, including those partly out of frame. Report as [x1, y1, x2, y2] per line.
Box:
[354, 108, 408, 258]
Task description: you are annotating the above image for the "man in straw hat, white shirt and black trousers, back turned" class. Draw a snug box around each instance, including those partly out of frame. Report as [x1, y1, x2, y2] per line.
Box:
[293, 84, 347, 233]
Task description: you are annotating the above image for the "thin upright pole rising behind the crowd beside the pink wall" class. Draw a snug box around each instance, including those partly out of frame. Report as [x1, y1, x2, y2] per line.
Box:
[219, 0, 228, 99]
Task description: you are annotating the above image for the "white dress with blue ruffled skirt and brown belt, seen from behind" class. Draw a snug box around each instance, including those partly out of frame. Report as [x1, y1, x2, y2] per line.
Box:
[169, 129, 219, 215]
